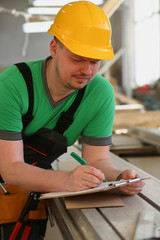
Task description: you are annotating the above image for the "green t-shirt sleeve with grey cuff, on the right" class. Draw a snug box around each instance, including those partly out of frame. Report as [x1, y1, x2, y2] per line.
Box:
[82, 77, 115, 145]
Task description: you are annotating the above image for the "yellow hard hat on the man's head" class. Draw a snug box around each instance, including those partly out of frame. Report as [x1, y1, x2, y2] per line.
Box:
[48, 1, 114, 60]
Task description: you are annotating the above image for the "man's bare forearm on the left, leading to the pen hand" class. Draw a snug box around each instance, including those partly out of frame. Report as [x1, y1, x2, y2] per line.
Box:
[2, 162, 68, 192]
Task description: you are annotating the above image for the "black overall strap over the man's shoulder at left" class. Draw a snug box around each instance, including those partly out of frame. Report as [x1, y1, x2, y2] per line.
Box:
[15, 62, 34, 129]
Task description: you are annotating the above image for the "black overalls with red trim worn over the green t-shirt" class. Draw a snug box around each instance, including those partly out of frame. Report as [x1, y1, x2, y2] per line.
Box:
[0, 63, 85, 240]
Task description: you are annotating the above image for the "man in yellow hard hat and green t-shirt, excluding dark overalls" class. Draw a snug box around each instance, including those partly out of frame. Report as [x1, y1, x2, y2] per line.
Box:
[0, 1, 144, 239]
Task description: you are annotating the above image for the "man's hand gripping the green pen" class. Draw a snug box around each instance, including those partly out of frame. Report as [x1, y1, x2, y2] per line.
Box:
[66, 165, 105, 191]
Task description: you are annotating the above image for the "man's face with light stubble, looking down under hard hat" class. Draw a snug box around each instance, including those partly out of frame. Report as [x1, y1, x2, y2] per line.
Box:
[54, 40, 100, 90]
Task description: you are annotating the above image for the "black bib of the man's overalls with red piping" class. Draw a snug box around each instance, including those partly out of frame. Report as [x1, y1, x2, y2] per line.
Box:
[23, 128, 67, 169]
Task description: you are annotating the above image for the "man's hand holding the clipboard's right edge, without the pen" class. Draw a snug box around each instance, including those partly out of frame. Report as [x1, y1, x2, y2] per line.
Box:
[117, 169, 145, 195]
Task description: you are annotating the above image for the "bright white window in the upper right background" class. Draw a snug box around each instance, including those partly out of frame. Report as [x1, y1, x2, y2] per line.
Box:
[134, 0, 160, 86]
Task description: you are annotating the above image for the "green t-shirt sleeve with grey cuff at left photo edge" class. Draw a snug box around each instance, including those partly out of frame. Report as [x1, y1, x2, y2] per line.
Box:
[0, 66, 26, 140]
